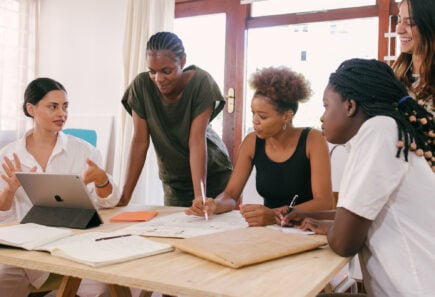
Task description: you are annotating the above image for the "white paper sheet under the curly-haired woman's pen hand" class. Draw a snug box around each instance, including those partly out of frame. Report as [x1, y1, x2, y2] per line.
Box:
[123, 211, 248, 238]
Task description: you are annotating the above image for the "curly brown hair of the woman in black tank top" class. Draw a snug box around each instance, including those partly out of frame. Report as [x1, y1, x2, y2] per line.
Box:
[250, 66, 311, 114]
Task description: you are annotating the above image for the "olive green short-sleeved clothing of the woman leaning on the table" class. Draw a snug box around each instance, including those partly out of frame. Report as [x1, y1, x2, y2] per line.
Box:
[122, 66, 232, 206]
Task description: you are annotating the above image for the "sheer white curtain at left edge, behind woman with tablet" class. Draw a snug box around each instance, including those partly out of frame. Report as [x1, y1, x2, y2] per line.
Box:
[0, 0, 39, 138]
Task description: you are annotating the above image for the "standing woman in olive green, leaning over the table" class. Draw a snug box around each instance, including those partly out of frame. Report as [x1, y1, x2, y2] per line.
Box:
[120, 32, 232, 207]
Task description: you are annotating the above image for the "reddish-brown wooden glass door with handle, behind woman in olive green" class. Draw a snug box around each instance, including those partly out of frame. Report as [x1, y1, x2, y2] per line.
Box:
[174, 0, 248, 161]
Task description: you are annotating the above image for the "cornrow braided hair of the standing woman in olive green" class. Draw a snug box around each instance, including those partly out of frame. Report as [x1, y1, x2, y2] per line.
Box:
[147, 32, 186, 60]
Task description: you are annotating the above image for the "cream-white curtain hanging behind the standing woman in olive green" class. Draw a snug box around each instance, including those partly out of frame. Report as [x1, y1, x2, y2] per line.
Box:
[114, 0, 175, 205]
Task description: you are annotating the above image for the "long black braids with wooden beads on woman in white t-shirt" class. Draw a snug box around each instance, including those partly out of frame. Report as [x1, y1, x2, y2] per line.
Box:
[329, 59, 435, 171]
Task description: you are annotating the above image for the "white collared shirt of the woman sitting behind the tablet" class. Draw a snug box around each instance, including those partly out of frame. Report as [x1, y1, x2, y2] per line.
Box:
[0, 131, 121, 223]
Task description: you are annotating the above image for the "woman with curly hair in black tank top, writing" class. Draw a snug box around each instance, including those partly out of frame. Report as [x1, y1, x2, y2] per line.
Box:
[187, 67, 333, 226]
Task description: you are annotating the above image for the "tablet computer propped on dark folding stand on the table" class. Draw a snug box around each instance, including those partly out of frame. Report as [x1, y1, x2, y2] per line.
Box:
[15, 172, 103, 229]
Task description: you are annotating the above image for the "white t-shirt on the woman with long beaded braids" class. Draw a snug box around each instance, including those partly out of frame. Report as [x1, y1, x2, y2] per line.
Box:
[337, 116, 435, 297]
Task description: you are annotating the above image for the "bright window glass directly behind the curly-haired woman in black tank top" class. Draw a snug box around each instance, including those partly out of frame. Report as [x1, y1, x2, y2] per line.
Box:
[244, 18, 378, 134]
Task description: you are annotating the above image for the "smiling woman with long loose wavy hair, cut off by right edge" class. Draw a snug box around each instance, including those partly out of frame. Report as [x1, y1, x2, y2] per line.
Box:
[393, 0, 435, 115]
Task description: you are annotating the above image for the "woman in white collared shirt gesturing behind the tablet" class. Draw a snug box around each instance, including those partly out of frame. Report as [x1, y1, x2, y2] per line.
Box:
[0, 78, 120, 297]
